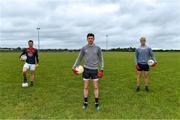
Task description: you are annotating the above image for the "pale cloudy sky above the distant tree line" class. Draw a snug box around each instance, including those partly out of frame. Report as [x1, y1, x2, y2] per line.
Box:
[0, 0, 180, 49]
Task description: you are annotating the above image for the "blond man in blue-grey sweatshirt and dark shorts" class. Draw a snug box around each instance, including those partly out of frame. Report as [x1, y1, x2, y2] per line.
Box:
[135, 37, 157, 92]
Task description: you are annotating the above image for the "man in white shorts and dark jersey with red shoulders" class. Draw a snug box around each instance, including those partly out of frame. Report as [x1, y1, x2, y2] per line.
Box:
[20, 40, 39, 87]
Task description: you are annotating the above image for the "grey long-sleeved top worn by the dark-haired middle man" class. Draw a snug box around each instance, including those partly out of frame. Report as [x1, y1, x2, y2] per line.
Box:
[73, 44, 104, 70]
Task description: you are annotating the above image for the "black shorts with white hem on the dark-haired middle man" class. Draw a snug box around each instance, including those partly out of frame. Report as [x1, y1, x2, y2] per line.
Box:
[83, 68, 98, 80]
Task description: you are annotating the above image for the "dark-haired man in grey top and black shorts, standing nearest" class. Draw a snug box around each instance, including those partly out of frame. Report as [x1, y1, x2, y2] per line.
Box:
[72, 33, 104, 111]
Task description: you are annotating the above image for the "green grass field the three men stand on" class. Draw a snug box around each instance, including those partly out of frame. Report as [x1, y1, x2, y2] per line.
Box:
[0, 52, 180, 119]
